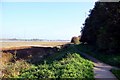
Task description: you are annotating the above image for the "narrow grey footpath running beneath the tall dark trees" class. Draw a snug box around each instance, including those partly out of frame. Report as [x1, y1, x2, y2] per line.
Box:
[76, 46, 118, 80]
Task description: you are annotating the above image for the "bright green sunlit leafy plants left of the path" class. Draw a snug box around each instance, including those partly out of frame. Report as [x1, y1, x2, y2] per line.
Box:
[19, 53, 93, 78]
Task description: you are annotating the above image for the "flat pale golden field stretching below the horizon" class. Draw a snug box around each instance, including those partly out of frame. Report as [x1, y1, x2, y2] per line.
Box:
[0, 41, 68, 49]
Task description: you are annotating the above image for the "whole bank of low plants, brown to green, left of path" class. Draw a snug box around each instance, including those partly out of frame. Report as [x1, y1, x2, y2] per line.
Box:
[0, 45, 94, 79]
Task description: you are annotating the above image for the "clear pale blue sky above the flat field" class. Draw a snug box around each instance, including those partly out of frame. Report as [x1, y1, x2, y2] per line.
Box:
[0, 1, 95, 40]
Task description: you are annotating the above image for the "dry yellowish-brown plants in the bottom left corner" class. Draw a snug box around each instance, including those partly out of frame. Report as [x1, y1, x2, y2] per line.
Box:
[2, 60, 30, 78]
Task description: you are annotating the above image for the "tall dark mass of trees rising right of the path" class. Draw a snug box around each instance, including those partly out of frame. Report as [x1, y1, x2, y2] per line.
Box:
[80, 2, 120, 53]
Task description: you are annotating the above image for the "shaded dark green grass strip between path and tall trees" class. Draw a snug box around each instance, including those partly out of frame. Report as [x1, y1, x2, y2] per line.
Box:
[76, 44, 120, 67]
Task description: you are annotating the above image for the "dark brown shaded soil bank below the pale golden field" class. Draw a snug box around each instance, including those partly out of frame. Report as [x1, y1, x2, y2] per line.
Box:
[1, 46, 59, 63]
